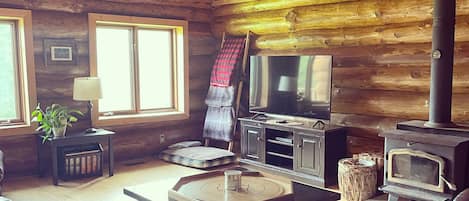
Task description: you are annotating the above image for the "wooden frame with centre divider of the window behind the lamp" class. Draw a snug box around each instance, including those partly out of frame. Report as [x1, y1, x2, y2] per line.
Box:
[88, 13, 189, 127]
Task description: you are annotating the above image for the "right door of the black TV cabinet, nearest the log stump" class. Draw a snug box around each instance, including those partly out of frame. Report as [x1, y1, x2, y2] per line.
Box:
[293, 133, 321, 175]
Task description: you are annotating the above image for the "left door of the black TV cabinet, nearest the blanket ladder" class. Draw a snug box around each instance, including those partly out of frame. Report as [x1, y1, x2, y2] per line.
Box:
[241, 126, 265, 162]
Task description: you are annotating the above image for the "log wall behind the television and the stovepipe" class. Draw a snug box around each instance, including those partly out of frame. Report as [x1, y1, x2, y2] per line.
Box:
[212, 0, 469, 153]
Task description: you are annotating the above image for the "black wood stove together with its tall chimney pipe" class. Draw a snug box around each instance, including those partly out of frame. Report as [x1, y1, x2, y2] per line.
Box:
[380, 0, 469, 201]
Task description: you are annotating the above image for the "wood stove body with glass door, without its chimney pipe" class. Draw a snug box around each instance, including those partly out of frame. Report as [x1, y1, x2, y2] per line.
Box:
[380, 120, 469, 201]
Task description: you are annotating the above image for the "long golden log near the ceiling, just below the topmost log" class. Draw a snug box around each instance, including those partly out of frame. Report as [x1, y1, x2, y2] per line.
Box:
[213, 0, 469, 35]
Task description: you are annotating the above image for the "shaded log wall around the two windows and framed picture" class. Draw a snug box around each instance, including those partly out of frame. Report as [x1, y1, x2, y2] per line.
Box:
[0, 0, 217, 175]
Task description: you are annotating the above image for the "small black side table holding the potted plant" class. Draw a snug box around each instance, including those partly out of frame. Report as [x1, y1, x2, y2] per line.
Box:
[37, 129, 115, 185]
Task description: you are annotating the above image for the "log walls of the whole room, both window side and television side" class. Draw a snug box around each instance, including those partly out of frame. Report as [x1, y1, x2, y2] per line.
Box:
[0, 0, 469, 174]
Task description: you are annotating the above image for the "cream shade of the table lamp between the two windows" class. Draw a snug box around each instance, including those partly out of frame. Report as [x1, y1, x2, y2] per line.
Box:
[73, 77, 102, 101]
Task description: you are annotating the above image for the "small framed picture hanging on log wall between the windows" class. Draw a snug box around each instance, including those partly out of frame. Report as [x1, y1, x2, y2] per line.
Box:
[43, 38, 78, 66]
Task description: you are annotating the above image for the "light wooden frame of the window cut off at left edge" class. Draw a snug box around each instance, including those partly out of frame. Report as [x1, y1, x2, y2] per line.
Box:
[0, 8, 37, 136]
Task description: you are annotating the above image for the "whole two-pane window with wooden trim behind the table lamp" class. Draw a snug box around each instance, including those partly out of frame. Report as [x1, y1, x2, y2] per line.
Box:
[90, 14, 188, 125]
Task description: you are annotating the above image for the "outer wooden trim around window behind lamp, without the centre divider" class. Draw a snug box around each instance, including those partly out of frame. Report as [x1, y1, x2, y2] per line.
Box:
[88, 13, 190, 127]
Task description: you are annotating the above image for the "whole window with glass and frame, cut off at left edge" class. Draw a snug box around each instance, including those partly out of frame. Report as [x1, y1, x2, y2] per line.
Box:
[0, 8, 36, 135]
